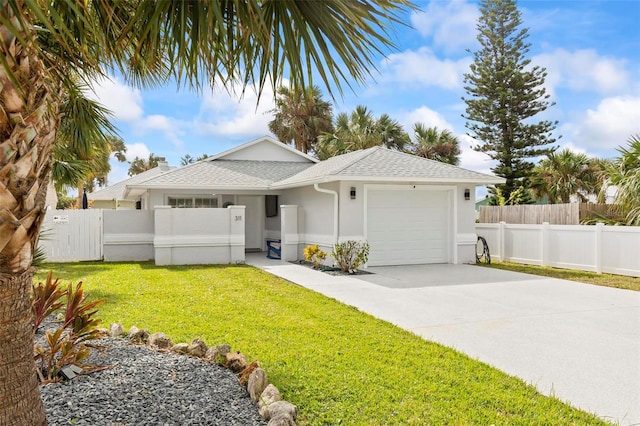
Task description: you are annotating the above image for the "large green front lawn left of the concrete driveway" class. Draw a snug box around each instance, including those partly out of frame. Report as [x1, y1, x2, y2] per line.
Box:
[38, 263, 606, 425]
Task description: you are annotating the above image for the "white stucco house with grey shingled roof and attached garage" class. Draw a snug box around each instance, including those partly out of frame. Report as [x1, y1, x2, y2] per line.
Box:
[90, 137, 503, 266]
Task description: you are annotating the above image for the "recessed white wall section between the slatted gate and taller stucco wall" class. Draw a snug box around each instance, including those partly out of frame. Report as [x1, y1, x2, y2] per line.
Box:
[102, 210, 154, 262]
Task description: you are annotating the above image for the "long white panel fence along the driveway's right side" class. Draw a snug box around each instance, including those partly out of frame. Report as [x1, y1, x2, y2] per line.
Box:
[476, 222, 640, 277]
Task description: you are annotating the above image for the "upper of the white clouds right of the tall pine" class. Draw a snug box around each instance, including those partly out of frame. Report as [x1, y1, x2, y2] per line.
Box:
[532, 49, 630, 95]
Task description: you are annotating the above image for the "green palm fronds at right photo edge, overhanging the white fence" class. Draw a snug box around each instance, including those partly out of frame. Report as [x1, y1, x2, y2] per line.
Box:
[607, 134, 640, 226]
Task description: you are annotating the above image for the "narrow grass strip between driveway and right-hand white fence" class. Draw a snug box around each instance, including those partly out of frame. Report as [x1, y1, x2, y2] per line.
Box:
[480, 261, 640, 291]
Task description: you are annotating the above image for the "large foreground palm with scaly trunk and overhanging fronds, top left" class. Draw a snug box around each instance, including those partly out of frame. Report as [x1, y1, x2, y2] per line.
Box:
[0, 0, 413, 425]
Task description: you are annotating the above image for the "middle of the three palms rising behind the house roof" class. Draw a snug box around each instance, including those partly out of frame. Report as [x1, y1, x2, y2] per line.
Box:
[316, 105, 411, 160]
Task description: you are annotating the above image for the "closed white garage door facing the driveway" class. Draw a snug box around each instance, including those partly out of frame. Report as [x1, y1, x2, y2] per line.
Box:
[367, 189, 451, 266]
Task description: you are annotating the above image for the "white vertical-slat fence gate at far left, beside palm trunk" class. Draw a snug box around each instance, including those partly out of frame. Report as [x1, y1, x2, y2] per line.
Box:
[40, 209, 102, 262]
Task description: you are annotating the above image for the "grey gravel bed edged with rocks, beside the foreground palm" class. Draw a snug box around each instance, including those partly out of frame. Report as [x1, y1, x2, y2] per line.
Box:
[40, 338, 267, 426]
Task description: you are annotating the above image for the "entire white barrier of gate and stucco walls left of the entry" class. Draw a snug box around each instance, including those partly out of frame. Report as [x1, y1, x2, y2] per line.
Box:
[40, 206, 245, 265]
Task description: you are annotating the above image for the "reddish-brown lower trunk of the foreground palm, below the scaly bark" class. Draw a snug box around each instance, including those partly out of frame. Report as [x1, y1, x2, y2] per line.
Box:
[0, 271, 46, 425]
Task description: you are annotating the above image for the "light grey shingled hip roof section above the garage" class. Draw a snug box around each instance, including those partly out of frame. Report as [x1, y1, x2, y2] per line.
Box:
[273, 146, 504, 188]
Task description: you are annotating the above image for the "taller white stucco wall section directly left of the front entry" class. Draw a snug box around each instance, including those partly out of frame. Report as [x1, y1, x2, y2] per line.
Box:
[153, 206, 245, 265]
